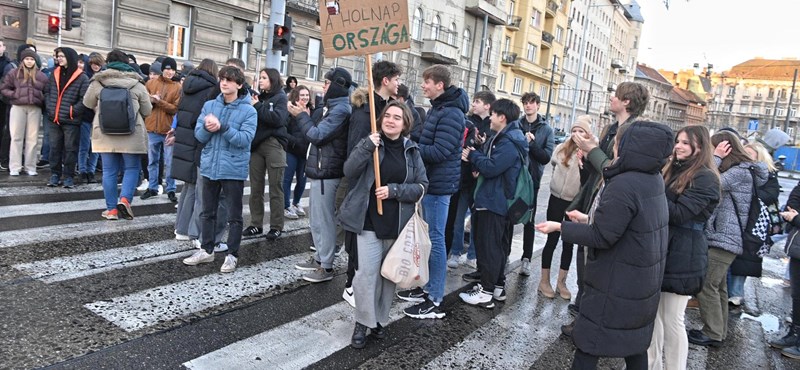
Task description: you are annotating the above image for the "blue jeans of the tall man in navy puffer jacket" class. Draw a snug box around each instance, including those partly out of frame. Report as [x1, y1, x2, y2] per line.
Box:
[422, 194, 446, 303]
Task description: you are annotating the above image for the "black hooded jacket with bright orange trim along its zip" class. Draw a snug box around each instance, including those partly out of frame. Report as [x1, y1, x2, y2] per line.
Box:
[44, 48, 89, 125]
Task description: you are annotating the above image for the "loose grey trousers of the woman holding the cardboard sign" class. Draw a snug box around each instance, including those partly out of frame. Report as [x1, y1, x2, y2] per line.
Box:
[353, 230, 395, 328]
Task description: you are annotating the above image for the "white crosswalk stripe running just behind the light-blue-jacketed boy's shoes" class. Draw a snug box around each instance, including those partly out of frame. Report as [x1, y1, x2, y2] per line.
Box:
[11, 218, 308, 284]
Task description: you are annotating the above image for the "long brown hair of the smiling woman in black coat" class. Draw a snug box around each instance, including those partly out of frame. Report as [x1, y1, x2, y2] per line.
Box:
[662, 126, 719, 194]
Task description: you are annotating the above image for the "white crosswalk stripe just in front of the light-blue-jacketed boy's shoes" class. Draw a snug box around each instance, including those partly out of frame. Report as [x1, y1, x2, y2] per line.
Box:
[84, 252, 347, 332]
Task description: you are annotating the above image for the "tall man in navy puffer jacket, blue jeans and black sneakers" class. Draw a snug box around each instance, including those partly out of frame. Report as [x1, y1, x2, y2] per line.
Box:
[397, 64, 469, 319]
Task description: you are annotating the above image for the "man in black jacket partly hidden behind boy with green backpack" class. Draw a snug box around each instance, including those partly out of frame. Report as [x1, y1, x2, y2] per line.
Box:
[444, 91, 494, 268]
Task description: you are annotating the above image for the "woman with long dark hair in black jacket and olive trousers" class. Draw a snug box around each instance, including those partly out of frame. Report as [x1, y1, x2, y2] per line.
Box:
[242, 68, 289, 240]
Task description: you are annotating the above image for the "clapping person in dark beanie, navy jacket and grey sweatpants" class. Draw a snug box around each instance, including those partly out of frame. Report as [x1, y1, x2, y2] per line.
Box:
[289, 67, 353, 283]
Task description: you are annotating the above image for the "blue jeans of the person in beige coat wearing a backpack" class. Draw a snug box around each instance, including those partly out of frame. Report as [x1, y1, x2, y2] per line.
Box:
[102, 153, 142, 210]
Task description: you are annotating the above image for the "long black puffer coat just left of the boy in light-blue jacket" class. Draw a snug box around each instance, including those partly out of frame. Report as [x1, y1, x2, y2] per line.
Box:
[172, 69, 219, 184]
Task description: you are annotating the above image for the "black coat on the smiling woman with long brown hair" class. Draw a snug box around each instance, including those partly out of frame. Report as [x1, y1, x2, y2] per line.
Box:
[661, 164, 720, 295]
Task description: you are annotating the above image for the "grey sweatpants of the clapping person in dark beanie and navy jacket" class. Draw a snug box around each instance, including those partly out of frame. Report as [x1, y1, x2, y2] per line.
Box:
[308, 179, 342, 269]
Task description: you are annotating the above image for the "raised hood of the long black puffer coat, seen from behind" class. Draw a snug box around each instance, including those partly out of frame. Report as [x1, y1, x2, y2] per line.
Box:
[603, 121, 675, 179]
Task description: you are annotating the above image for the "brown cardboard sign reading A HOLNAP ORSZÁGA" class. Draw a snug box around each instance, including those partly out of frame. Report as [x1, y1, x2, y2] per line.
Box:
[320, 0, 410, 57]
